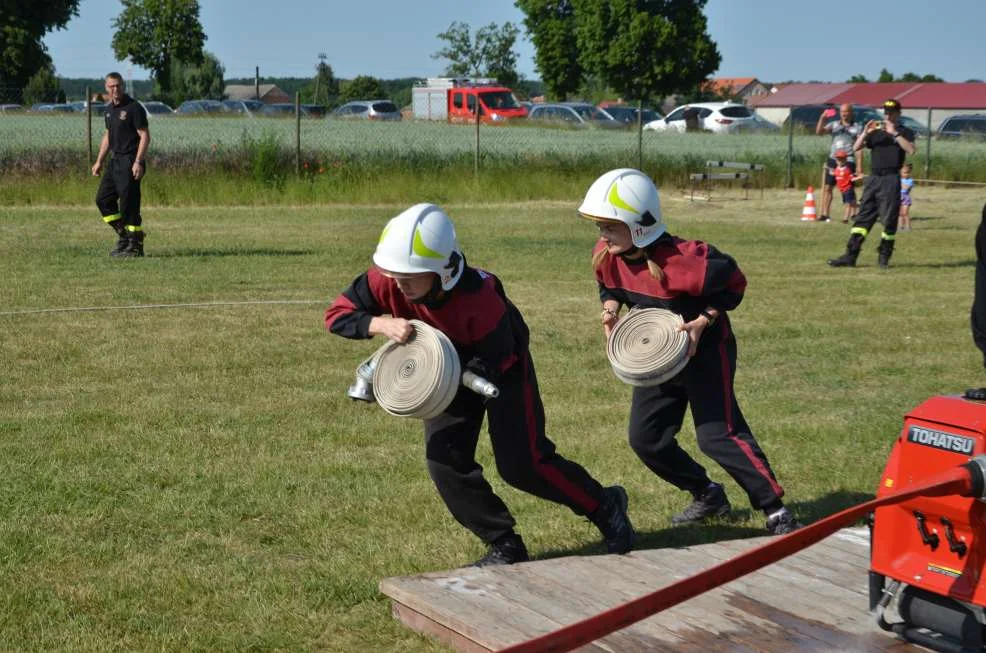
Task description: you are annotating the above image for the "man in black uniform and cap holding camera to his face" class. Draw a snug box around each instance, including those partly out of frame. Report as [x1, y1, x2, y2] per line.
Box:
[828, 100, 914, 268]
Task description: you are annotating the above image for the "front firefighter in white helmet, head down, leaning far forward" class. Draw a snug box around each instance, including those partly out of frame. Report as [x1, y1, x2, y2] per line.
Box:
[325, 204, 634, 566]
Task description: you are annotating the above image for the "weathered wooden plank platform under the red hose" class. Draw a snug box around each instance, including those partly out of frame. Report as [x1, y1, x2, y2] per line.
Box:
[380, 528, 925, 653]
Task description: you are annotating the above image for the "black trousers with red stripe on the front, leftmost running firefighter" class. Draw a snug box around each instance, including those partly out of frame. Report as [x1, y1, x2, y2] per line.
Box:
[424, 352, 603, 544]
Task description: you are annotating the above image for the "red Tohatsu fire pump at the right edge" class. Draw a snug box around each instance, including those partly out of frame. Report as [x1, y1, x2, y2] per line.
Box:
[869, 396, 986, 653]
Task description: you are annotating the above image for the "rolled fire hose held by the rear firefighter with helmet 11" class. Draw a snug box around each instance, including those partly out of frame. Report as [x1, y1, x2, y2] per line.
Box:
[606, 308, 688, 386]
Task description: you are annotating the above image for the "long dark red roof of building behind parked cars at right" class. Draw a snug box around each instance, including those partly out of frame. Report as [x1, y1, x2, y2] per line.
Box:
[757, 82, 986, 110]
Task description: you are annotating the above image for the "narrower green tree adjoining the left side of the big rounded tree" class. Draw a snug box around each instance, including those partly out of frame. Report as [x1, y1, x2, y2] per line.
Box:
[514, 0, 584, 100]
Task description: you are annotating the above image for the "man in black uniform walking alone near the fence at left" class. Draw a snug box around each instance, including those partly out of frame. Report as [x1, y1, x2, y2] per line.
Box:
[92, 73, 151, 257]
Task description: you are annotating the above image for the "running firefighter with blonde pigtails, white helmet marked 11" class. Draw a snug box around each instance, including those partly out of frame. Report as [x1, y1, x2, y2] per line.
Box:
[578, 169, 800, 534]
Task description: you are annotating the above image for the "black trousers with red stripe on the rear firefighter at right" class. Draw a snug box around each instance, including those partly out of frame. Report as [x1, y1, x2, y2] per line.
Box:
[629, 320, 784, 510]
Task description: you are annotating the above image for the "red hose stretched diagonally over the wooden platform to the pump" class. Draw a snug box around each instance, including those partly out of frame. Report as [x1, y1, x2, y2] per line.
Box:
[500, 467, 973, 653]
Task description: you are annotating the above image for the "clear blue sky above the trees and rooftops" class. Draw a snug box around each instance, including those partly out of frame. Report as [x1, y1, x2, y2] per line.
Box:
[44, 0, 986, 82]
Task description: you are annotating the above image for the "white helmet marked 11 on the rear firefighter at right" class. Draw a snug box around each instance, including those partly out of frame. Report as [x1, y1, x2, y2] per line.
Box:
[579, 168, 667, 247]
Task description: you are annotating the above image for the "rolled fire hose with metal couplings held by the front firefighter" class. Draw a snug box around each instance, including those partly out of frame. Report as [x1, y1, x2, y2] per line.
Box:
[348, 320, 500, 419]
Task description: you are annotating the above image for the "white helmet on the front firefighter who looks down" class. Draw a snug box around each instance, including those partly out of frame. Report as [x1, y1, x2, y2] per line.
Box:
[373, 204, 465, 290]
